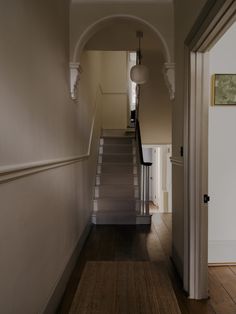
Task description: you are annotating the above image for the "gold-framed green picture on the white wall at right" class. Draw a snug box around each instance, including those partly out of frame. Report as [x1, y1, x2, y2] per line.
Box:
[212, 74, 236, 106]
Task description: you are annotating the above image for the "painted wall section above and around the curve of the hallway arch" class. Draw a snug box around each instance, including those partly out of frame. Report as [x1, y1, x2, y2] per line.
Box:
[70, 1, 174, 61]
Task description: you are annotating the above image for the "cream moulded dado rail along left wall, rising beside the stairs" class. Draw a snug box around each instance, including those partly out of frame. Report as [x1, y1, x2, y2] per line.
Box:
[0, 87, 101, 184]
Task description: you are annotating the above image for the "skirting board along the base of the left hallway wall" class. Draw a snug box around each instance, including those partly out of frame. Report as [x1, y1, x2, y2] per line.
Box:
[43, 220, 92, 314]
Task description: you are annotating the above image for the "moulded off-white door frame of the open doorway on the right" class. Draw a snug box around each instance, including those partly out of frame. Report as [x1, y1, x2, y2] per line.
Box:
[184, 0, 236, 299]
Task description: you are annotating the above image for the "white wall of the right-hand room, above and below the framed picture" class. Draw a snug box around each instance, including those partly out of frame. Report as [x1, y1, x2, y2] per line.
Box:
[208, 23, 236, 263]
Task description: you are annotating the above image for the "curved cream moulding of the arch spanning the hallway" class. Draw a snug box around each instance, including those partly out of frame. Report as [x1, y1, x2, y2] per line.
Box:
[72, 14, 172, 63]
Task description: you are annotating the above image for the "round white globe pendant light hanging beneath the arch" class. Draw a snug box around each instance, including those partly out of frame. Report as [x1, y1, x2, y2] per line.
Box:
[130, 31, 149, 84]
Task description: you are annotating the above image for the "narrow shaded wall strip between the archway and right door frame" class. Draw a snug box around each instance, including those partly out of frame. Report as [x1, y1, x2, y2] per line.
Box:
[172, 0, 206, 277]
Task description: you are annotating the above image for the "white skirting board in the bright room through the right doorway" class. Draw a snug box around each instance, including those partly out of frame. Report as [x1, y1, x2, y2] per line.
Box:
[208, 240, 236, 265]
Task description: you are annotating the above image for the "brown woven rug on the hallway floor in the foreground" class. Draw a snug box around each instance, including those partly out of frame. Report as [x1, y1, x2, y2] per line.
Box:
[70, 262, 181, 314]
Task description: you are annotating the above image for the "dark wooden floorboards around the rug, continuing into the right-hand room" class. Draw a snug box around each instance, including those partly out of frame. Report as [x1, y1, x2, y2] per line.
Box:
[57, 213, 236, 314]
